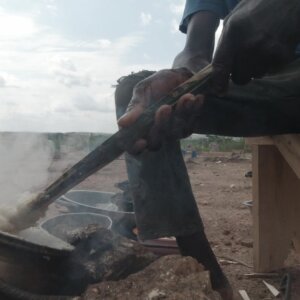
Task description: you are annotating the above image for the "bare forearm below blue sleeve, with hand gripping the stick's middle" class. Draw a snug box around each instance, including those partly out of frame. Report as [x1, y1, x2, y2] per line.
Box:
[118, 11, 219, 152]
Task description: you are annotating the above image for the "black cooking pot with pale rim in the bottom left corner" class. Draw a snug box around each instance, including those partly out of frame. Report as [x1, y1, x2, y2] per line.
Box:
[0, 232, 73, 295]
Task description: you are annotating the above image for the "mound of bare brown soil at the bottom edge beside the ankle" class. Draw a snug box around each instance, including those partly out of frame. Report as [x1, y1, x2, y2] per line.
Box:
[82, 255, 220, 300]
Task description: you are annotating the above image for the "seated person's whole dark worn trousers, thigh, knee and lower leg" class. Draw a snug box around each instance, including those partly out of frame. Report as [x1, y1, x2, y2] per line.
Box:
[115, 59, 300, 239]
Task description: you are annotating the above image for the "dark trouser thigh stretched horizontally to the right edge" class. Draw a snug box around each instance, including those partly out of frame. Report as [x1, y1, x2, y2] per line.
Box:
[193, 59, 300, 137]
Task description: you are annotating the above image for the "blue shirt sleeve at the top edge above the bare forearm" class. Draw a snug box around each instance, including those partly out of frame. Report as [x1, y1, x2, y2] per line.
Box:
[179, 0, 300, 56]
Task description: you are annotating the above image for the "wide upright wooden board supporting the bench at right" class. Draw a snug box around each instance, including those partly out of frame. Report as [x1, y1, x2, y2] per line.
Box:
[253, 145, 300, 272]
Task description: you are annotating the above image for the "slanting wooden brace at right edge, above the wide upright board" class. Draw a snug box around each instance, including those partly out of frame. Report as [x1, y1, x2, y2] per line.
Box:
[272, 134, 300, 178]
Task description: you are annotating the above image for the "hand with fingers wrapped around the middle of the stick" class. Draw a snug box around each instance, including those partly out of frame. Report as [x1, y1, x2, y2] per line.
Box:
[118, 68, 203, 153]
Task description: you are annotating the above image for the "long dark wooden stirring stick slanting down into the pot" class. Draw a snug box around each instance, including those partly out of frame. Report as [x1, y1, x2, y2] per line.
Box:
[11, 65, 212, 232]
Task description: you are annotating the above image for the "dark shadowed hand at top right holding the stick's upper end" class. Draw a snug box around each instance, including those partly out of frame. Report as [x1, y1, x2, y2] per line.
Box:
[213, 0, 300, 93]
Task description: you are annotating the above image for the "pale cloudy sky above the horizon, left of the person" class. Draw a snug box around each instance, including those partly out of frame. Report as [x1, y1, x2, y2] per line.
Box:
[0, 0, 220, 133]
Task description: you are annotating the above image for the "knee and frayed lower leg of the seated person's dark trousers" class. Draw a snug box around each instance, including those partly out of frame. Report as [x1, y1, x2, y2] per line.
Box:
[115, 71, 203, 240]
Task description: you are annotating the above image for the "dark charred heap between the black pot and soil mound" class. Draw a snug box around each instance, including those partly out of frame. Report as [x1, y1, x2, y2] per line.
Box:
[66, 225, 157, 290]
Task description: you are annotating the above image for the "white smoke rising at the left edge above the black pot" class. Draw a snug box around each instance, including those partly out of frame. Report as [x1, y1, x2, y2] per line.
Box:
[0, 133, 54, 228]
